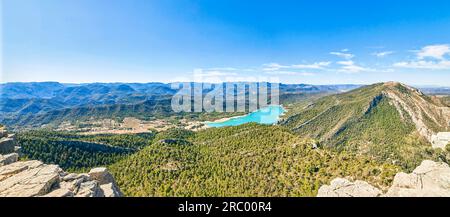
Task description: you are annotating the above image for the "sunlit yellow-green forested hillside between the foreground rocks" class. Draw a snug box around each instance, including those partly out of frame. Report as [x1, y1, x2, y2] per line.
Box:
[110, 124, 399, 196]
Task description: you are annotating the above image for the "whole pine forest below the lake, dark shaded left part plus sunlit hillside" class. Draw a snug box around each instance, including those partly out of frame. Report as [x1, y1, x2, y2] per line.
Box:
[18, 124, 399, 196]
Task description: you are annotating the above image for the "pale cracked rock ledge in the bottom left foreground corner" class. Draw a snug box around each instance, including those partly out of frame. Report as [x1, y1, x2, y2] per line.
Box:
[0, 127, 122, 197]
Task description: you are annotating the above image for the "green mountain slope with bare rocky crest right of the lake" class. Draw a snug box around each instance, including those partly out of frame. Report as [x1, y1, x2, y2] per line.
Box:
[282, 82, 450, 168]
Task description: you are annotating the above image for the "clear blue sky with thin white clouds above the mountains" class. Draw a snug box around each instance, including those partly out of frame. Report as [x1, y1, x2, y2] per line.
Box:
[1, 0, 450, 86]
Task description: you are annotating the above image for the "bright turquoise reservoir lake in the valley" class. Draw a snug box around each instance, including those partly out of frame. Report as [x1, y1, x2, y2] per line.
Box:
[206, 105, 285, 127]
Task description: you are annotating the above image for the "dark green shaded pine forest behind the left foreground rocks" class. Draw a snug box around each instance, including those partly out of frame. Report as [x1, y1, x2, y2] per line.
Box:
[17, 130, 155, 171]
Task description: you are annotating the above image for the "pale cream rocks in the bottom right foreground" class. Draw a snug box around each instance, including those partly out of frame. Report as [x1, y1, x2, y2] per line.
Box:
[317, 160, 450, 197]
